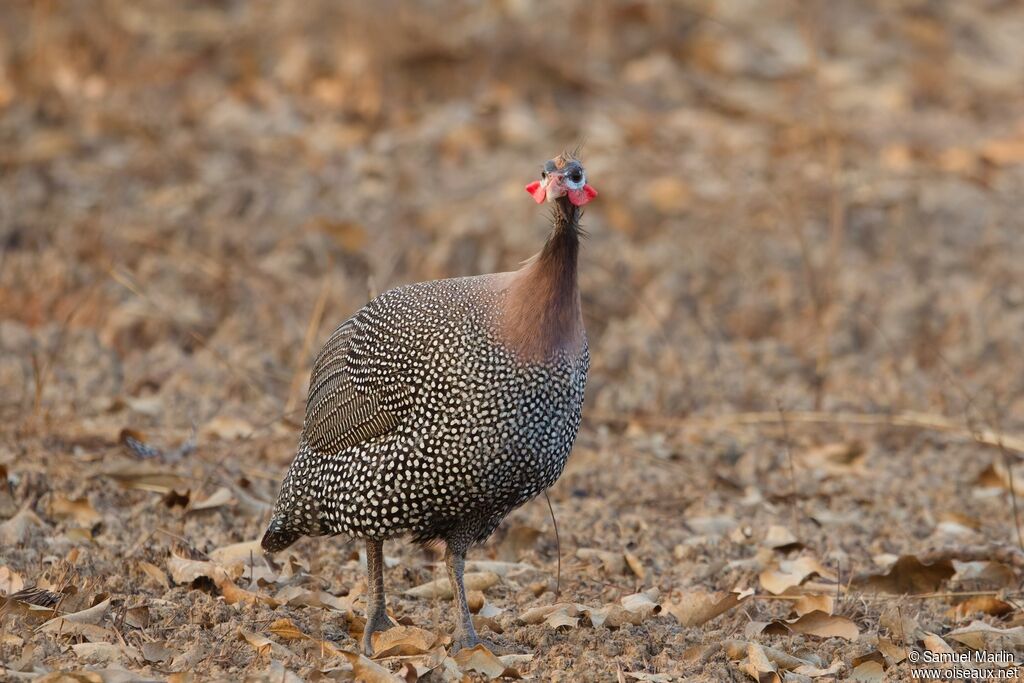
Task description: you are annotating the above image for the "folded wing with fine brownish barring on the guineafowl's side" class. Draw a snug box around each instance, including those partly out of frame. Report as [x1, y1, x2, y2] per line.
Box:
[303, 309, 415, 456]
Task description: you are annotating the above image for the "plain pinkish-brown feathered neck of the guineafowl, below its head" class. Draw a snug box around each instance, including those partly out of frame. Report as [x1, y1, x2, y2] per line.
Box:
[502, 197, 584, 360]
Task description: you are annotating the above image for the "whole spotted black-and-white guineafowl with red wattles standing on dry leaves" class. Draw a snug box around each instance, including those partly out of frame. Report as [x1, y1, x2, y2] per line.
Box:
[262, 154, 597, 653]
